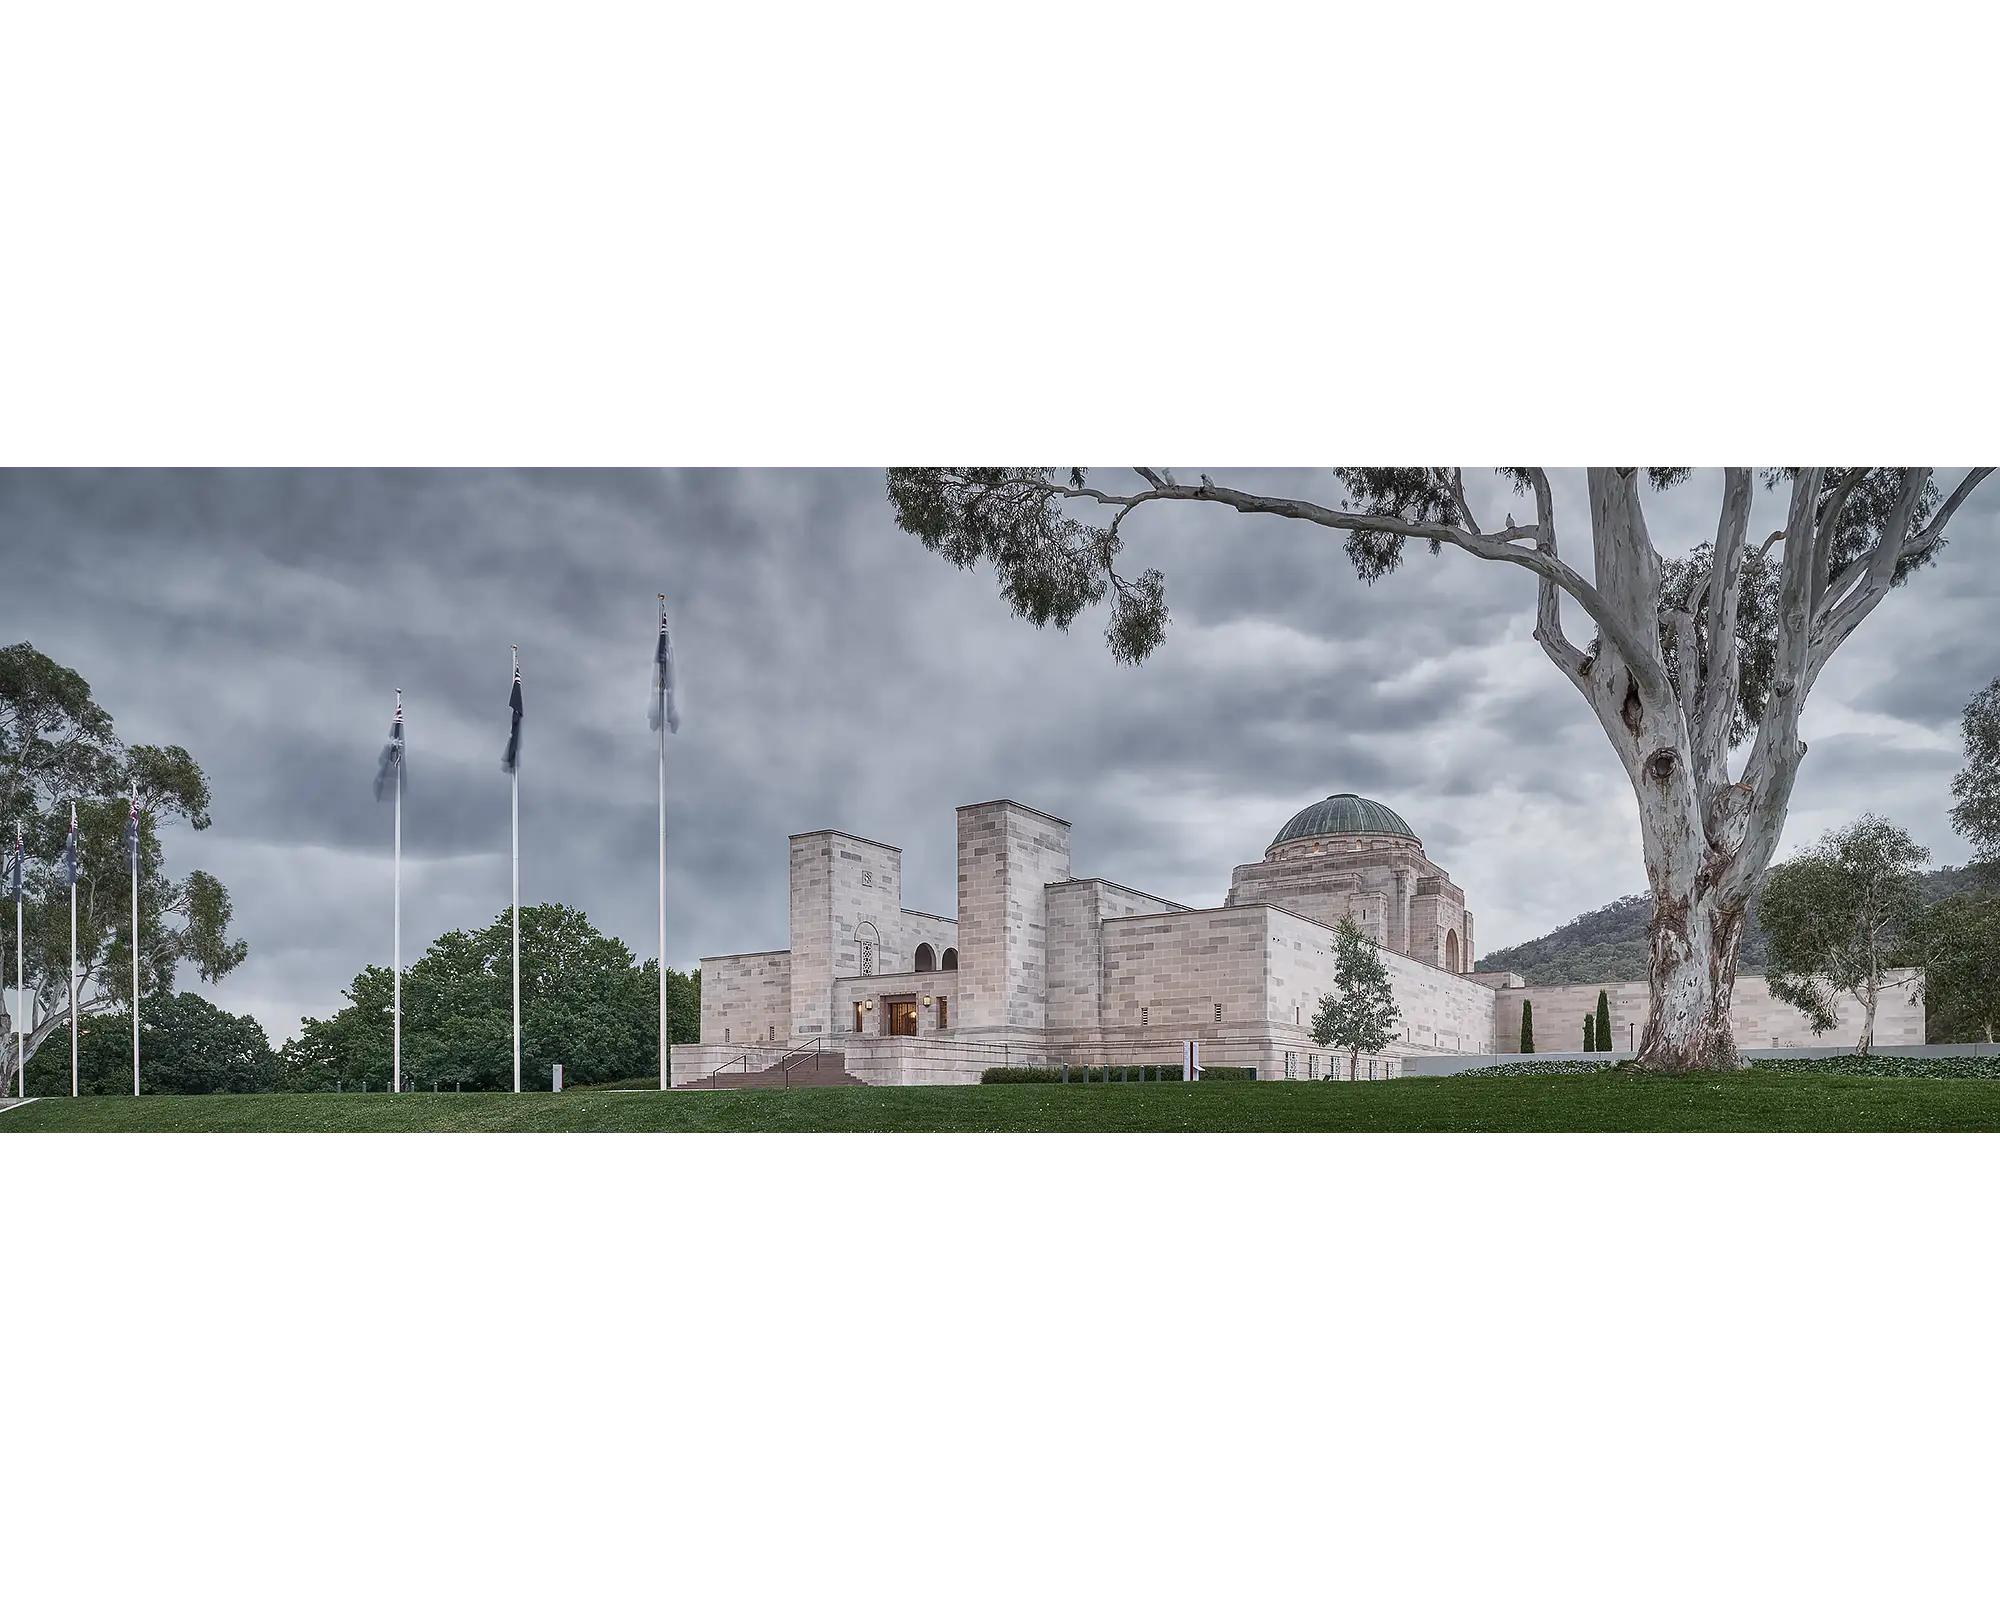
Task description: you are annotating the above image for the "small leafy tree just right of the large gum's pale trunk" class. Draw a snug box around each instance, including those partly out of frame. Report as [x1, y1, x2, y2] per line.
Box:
[1758, 814, 1930, 1056]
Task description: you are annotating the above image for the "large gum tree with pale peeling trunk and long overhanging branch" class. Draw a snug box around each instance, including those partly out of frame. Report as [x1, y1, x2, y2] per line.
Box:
[888, 466, 1990, 1072]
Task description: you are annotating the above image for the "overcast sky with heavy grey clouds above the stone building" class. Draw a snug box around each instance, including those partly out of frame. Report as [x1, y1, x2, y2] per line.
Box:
[0, 468, 2000, 1042]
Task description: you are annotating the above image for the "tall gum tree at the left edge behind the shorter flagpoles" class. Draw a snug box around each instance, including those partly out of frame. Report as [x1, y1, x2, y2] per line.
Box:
[0, 642, 246, 1086]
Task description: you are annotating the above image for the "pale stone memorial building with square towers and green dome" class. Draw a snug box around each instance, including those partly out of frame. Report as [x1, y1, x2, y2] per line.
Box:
[674, 794, 1924, 1084]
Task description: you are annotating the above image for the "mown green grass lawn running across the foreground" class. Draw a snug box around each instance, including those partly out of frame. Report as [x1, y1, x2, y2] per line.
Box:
[0, 1072, 2000, 1136]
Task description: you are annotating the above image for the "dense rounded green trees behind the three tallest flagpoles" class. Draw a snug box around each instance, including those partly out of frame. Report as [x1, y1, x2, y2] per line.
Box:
[278, 906, 702, 1090]
